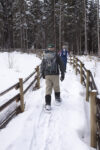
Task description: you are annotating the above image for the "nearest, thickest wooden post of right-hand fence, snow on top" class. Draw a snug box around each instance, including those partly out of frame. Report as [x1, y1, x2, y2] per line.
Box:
[90, 91, 97, 148]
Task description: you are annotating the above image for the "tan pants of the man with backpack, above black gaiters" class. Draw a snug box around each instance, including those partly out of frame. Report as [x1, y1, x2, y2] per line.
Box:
[45, 75, 60, 95]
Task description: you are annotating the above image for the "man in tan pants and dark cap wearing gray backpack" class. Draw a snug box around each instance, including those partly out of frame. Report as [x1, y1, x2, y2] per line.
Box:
[41, 44, 65, 111]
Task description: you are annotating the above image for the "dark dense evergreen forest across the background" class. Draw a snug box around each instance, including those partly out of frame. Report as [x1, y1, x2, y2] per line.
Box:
[0, 0, 99, 54]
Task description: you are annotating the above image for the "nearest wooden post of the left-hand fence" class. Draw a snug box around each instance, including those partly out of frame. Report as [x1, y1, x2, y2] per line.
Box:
[19, 78, 24, 112]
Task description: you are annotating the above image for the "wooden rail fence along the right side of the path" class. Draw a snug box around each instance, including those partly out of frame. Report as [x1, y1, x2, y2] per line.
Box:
[70, 56, 100, 150]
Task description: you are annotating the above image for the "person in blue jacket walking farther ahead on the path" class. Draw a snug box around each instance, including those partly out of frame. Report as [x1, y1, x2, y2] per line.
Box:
[60, 45, 68, 70]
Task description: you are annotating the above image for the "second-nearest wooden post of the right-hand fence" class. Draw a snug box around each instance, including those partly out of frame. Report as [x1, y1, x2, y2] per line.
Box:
[86, 70, 90, 101]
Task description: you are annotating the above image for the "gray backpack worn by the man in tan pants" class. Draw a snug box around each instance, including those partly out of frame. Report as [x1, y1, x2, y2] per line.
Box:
[44, 52, 57, 74]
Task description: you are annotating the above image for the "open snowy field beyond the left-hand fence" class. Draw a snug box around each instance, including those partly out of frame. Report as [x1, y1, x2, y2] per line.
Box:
[0, 52, 41, 91]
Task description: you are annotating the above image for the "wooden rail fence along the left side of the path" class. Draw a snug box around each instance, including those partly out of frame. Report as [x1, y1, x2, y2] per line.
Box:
[0, 66, 41, 129]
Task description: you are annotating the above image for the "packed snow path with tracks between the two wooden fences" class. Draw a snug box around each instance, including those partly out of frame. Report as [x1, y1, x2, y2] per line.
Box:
[0, 64, 92, 150]
